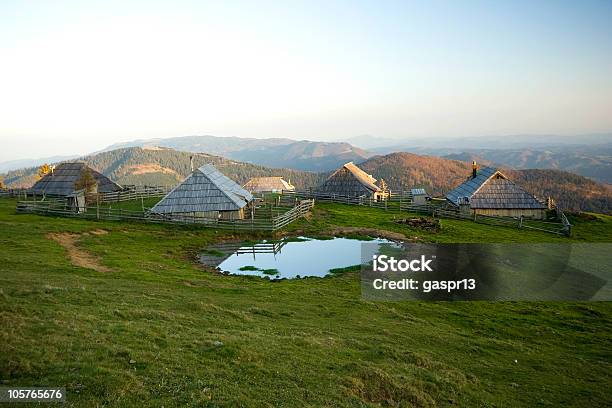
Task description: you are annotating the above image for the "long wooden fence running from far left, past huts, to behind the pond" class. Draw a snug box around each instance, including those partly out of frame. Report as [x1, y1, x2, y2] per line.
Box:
[17, 200, 314, 231]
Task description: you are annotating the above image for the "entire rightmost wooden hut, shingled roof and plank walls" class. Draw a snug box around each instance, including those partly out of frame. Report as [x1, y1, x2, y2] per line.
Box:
[446, 163, 546, 219]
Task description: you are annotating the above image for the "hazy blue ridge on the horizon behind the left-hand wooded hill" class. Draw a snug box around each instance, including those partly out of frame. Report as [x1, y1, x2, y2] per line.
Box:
[103, 136, 372, 171]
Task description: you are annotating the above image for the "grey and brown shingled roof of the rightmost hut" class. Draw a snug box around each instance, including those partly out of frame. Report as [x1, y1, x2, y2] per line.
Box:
[446, 167, 546, 209]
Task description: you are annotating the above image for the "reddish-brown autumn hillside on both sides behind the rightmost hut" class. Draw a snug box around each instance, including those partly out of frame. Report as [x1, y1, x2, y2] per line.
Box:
[360, 152, 612, 214]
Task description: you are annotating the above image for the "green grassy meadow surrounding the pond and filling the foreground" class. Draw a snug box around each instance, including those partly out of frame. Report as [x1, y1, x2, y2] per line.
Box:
[0, 199, 612, 407]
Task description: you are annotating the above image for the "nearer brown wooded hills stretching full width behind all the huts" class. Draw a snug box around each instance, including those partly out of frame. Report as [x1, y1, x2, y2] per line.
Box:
[4, 147, 612, 213]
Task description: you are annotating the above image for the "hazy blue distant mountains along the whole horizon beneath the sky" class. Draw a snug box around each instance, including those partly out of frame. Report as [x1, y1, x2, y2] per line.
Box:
[0, 134, 612, 184]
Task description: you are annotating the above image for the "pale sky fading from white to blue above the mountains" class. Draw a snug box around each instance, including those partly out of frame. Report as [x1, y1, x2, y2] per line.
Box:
[0, 0, 612, 161]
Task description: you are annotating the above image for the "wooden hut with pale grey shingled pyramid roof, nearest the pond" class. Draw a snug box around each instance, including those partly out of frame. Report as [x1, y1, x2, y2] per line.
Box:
[151, 164, 253, 220]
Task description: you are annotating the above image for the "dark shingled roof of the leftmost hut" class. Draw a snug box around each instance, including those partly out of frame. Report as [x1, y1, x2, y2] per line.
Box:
[30, 162, 122, 196]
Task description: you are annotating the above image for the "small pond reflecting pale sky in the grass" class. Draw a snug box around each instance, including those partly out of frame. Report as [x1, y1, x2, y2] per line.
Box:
[200, 237, 399, 279]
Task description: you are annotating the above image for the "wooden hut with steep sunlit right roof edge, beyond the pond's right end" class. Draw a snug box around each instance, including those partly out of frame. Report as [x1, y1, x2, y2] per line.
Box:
[317, 162, 388, 200]
